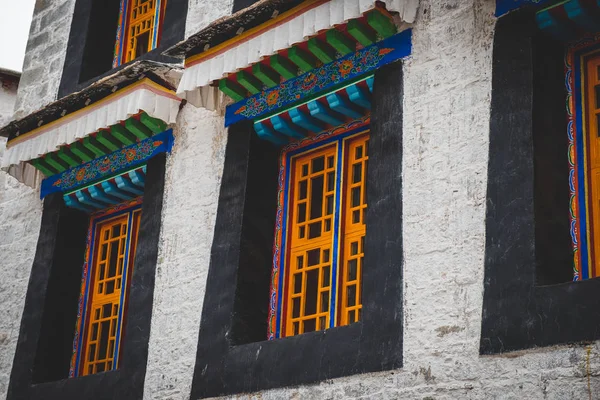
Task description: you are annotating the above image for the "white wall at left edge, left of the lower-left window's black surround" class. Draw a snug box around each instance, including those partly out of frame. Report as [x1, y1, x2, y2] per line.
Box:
[0, 137, 42, 399]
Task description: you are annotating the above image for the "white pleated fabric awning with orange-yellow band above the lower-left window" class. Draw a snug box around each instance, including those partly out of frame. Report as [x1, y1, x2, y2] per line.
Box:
[0, 78, 181, 187]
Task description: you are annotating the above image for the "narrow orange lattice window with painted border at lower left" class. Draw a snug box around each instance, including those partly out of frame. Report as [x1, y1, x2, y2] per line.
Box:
[69, 202, 142, 377]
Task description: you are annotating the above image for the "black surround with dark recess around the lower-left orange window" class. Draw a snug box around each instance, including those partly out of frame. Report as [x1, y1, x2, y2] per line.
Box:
[7, 154, 166, 400]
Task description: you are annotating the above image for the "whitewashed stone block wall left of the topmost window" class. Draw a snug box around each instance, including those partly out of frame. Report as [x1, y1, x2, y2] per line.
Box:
[15, 0, 75, 118]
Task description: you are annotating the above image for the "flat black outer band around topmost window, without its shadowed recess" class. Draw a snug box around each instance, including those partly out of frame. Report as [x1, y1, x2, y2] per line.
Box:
[58, 0, 188, 98]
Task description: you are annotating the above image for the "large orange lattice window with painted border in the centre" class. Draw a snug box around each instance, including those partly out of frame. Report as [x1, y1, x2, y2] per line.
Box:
[269, 128, 369, 338]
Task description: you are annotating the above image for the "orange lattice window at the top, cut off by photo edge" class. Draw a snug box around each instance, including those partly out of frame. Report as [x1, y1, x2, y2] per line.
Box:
[113, 0, 167, 68]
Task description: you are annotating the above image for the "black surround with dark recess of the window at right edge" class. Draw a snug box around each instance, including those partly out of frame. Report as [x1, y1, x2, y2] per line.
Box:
[480, 11, 600, 354]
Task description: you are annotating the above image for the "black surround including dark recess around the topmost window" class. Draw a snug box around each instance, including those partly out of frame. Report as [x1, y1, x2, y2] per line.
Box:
[58, 0, 188, 98]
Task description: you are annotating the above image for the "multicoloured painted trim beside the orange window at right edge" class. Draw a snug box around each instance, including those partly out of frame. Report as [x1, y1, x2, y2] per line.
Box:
[565, 34, 600, 281]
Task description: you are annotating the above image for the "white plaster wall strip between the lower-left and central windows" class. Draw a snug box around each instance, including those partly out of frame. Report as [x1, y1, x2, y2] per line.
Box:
[144, 105, 227, 400]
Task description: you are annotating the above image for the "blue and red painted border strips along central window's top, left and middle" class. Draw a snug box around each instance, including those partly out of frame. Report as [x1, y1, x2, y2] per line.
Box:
[275, 125, 370, 338]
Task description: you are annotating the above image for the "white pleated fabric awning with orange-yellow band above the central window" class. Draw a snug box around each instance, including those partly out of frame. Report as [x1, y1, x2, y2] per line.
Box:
[177, 0, 419, 110]
